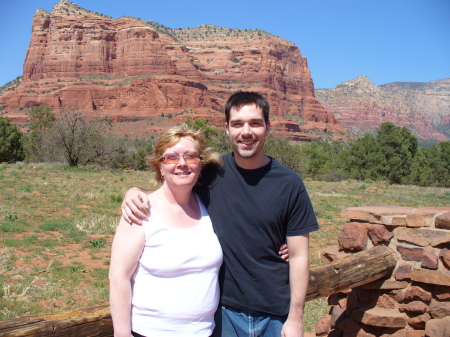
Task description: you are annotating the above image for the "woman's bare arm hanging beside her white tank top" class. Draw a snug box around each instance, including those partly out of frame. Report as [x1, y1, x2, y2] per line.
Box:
[109, 217, 145, 337]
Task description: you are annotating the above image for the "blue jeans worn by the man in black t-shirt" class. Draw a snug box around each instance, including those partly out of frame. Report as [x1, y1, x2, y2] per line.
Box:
[212, 306, 287, 337]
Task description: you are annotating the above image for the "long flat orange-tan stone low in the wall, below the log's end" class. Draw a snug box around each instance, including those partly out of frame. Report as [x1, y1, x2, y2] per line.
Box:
[351, 307, 407, 328]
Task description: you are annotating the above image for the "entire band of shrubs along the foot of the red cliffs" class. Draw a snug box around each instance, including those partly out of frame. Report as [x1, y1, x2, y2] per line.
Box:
[0, 106, 450, 187]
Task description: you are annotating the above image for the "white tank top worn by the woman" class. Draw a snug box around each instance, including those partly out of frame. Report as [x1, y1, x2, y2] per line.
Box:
[131, 197, 223, 337]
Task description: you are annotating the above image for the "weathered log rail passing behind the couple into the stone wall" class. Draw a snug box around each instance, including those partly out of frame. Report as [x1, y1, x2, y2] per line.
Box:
[0, 246, 397, 337]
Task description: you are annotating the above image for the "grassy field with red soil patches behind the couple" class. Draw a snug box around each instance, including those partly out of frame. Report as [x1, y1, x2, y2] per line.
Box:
[0, 163, 450, 331]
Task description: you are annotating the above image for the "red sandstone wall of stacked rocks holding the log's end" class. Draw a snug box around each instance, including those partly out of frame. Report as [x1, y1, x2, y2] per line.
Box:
[315, 207, 450, 337]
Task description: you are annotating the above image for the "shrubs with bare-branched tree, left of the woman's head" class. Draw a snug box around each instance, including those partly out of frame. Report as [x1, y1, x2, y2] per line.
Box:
[0, 106, 153, 170]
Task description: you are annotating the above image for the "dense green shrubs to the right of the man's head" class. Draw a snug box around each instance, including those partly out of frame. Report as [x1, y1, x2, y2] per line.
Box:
[266, 122, 450, 187]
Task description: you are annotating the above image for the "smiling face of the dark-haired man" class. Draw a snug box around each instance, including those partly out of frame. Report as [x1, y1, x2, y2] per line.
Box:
[226, 104, 270, 161]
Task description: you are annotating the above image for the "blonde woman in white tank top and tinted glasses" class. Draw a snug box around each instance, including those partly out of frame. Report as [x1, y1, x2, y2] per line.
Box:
[109, 127, 222, 337]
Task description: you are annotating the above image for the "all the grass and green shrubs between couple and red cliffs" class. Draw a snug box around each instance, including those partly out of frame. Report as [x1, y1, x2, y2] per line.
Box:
[0, 107, 450, 331]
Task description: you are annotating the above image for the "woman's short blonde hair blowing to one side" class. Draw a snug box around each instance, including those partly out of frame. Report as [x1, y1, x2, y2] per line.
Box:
[148, 125, 222, 184]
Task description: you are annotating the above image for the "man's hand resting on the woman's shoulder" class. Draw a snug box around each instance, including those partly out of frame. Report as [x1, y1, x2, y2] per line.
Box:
[122, 187, 150, 225]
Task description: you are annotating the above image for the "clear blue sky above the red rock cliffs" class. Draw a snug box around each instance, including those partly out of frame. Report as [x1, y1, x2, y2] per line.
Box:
[0, 0, 450, 89]
